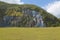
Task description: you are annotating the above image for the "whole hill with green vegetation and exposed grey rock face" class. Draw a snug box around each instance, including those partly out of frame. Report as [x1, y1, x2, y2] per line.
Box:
[0, 2, 60, 27]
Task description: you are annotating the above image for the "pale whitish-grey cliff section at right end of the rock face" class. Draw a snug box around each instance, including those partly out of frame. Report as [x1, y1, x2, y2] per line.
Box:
[32, 11, 44, 27]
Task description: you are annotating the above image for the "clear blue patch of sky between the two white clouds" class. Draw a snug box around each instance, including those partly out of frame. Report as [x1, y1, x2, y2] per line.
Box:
[22, 0, 55, 7]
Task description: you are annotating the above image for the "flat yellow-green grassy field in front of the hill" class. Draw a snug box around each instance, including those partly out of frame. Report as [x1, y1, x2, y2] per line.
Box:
[0, 28, 60, 40]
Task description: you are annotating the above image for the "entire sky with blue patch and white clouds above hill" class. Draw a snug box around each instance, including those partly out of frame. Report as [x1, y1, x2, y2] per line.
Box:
[0, 0, 60, 18]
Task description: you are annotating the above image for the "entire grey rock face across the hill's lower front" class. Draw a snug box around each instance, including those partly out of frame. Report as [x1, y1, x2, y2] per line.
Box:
[0, 8, 44, 27]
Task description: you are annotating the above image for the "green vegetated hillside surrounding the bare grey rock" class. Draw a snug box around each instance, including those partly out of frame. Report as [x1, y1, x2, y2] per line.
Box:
[0, 2, 60, 27]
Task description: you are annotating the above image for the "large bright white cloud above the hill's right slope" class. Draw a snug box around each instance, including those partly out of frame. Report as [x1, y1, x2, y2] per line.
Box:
[45, 1, 60, 18]
